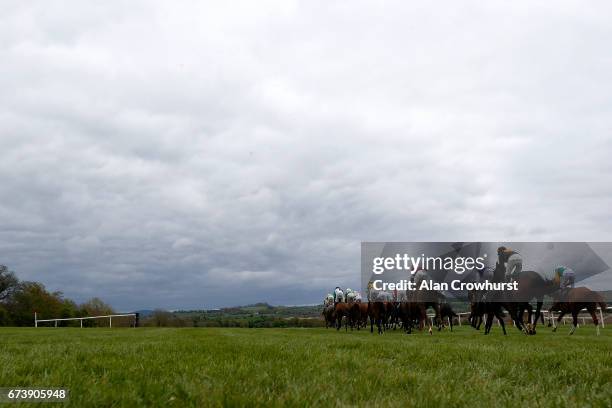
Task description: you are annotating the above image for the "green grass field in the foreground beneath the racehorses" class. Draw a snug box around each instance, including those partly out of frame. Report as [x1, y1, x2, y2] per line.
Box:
[0, 326, 612, 407]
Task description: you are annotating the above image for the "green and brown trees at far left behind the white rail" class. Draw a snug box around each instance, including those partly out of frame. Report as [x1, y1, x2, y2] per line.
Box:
[0, 265, 120, 327]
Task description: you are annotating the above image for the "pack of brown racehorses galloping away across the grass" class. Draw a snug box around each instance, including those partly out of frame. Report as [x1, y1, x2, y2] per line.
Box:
[323, 264, 606, 334]
